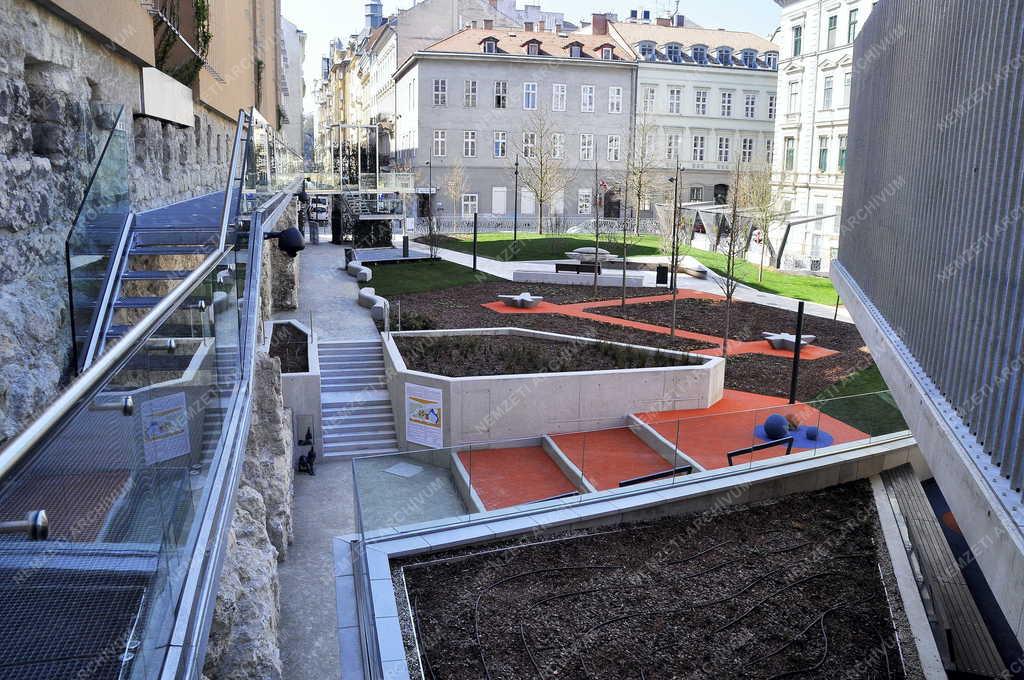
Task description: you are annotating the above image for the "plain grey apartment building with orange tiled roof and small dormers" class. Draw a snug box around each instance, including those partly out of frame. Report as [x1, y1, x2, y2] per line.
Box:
[395, 29, 636, 217]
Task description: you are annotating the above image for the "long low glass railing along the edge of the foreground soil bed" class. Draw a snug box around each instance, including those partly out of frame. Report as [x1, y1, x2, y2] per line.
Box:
[352, 392, 907, 533]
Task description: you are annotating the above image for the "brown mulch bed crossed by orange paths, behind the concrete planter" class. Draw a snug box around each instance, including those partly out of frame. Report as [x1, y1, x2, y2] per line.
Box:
[380, 282, 874, 401]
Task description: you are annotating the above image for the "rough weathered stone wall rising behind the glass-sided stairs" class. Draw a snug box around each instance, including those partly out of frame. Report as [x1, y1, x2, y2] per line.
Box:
[0, 0, 234, 441]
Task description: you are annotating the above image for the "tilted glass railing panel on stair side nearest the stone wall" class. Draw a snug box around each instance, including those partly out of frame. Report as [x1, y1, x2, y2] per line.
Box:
[65, 108, 131, 370]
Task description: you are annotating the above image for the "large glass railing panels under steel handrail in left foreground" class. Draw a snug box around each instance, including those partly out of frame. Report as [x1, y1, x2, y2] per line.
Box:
[0, 246, 241, 678]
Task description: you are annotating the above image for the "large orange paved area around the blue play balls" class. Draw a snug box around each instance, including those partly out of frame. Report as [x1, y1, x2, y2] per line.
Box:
[637, 389, 868, 470]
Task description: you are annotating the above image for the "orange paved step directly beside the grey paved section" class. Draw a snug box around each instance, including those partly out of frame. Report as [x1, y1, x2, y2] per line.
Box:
[459, 447, 577, 510]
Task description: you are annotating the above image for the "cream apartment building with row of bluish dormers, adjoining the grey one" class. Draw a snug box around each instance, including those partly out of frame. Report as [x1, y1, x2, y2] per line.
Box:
[591, 14, 779, 203]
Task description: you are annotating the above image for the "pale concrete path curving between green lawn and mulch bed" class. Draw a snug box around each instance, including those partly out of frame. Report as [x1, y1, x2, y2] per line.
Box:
[419, 240, 853, 323]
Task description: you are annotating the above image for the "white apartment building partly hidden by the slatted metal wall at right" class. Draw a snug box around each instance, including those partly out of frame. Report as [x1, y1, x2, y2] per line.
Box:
[773, 0, 876, 271]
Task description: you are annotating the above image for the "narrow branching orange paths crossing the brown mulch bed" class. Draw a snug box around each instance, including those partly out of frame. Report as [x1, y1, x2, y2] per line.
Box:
[483, 290, 839, 362]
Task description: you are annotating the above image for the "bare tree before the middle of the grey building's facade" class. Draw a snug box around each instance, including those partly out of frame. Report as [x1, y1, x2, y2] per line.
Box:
[508, 111, 575, 233]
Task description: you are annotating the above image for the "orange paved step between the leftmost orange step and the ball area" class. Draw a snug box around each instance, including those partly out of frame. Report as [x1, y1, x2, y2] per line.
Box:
[551, 427, 672, 491]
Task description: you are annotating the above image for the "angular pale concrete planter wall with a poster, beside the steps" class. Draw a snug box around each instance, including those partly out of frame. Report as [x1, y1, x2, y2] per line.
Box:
[384, 328, 725, 449]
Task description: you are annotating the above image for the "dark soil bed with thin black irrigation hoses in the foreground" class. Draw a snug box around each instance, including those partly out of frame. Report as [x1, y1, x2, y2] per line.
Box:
[396, 481, 920, 680]
